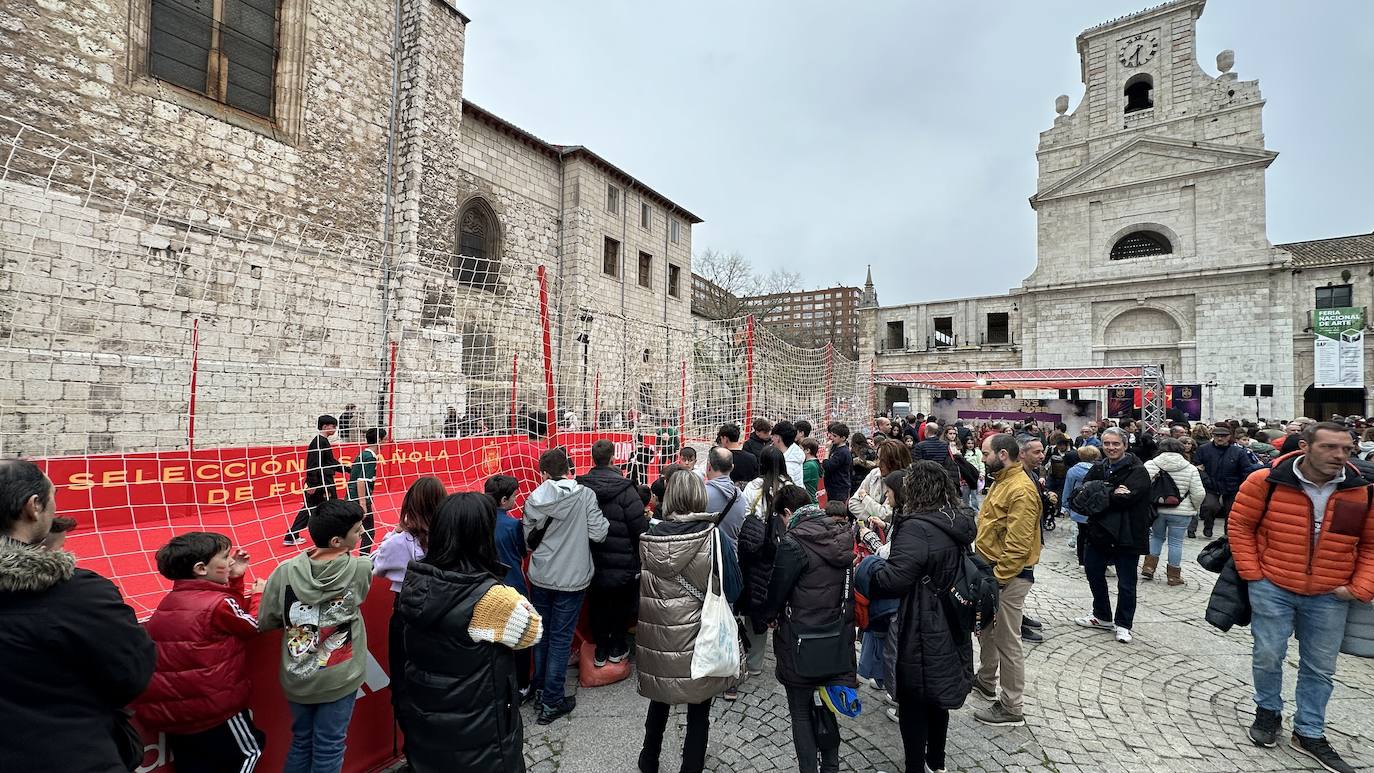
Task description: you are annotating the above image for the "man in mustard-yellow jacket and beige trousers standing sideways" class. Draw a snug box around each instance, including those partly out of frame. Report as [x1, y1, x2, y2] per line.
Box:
[973, 434, 1040, 726]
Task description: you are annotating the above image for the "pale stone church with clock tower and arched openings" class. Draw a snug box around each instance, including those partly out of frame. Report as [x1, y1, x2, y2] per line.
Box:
[860, 0, 1374, 417]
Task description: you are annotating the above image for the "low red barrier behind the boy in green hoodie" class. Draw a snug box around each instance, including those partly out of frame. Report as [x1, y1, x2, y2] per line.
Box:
[137, 579, 400, 773]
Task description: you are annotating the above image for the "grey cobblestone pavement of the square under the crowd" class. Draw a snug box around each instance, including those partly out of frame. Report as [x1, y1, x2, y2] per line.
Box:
[525, 531, 1374, 773]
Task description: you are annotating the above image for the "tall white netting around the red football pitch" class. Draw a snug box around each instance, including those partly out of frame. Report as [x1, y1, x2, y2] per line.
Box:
[0, 119, 868, 614]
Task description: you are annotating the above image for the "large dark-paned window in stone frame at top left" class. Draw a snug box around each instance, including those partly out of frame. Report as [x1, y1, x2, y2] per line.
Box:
[148, 0, 280, 118]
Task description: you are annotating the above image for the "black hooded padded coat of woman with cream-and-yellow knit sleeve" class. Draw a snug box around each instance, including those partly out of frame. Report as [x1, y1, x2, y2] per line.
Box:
[396, 562, 525, 773]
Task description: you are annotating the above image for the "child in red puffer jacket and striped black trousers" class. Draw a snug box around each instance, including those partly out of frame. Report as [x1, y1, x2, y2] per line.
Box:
[135, 531, 267, 773]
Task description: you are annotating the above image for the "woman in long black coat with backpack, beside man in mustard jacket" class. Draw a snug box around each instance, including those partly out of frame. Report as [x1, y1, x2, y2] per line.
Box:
[871, 460, 977, 770]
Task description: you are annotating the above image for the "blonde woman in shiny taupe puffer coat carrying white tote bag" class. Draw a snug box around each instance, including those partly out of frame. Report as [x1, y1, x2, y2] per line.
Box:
[635, 475, 741, 773]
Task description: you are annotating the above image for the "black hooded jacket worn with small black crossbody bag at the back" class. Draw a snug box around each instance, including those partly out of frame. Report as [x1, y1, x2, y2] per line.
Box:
[765, 505, 859, 687]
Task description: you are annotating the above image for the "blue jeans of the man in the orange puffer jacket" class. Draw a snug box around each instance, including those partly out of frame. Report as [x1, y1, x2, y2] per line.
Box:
[1249, 579, 1351, 739]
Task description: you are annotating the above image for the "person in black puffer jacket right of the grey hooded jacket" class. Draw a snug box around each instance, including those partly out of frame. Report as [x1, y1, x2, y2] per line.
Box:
[577, 441, 649, 667]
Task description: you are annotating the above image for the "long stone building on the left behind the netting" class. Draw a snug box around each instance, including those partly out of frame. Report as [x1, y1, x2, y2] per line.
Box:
[0, 0, 699, 456]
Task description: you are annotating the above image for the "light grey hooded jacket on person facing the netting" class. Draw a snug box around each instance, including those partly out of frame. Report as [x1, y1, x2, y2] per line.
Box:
[525, 478, 610, 592]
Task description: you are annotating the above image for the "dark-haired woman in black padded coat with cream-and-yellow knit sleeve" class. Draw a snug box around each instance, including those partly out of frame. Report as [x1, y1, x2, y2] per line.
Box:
[397, 493, 543, 773]
